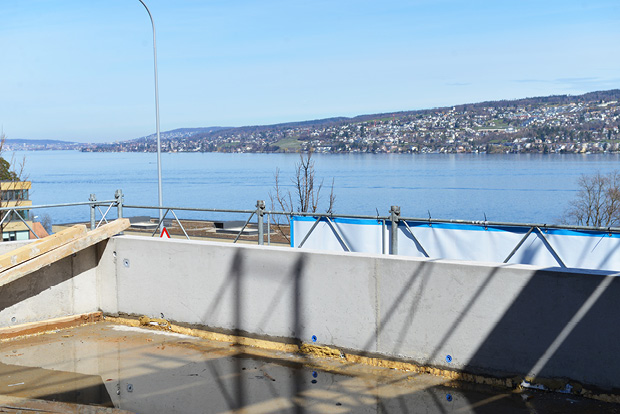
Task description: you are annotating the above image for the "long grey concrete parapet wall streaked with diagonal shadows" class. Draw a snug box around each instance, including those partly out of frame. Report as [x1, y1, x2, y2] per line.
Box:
[105, 236, 620, 392]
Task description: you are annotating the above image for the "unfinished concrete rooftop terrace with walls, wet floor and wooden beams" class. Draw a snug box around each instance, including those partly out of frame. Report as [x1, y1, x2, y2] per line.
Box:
[0, 218, 620, 413]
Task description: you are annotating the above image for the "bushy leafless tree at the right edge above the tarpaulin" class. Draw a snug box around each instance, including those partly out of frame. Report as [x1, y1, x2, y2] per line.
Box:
[562, 170, 620, 227]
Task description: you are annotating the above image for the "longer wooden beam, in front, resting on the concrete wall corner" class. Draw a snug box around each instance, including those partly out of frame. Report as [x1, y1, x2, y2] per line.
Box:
[0, 219, 130, 286]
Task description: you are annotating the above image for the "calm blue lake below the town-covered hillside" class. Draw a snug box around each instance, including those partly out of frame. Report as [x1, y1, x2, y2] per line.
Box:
[14, 151, 620, 224]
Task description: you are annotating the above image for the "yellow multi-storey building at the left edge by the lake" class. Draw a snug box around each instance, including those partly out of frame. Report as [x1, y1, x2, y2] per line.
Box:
[0, 181, 32, 241]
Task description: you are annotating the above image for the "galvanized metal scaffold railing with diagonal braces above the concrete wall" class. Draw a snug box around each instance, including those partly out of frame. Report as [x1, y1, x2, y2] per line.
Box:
[0, 190, 620, 267]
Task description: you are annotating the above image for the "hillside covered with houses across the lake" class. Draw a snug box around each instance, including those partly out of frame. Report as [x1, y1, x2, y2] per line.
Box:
[27, 90, 620, 153]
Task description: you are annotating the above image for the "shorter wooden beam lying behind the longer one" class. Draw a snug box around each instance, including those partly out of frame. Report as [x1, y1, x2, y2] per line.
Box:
[0, 224, 86, 272]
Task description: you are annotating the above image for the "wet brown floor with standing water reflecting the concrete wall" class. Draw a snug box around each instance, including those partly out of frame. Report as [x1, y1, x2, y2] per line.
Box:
[0, 322, 620, 413]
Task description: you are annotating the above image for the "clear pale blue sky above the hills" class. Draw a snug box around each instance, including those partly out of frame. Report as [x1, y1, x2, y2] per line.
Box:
[0, 0, 620, 142]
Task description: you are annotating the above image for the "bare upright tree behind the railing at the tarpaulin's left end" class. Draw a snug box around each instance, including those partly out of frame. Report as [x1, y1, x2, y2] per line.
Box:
[269, 150, 336, 243]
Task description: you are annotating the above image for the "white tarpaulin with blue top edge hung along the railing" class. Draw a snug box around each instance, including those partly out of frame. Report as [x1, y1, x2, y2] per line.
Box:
[291, 216, 620, 271]
